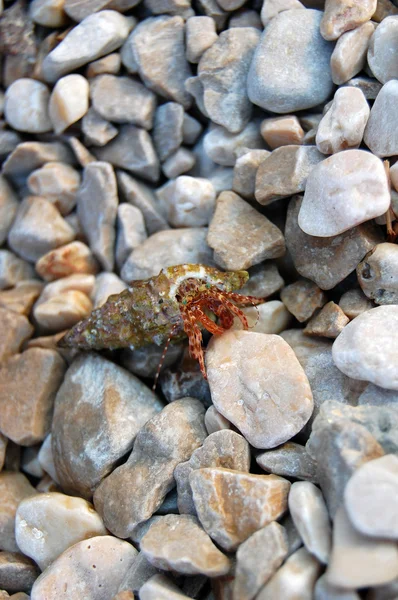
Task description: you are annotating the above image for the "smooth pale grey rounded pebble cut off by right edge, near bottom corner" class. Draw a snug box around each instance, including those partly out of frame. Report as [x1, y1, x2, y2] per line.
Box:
[344, 454, 398, 539]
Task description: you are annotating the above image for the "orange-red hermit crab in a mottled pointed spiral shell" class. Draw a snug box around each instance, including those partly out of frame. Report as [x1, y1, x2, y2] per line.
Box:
[58, 264, 263, 382]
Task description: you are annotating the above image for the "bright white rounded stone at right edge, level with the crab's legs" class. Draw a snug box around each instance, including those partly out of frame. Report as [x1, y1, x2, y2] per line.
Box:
[332, 304, 398, 390]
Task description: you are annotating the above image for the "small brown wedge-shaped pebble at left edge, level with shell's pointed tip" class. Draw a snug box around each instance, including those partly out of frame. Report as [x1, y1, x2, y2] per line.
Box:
[0, 307, 34, 362]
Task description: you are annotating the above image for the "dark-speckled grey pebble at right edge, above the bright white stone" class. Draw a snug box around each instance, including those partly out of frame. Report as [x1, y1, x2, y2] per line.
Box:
[357, 243, 398, 304]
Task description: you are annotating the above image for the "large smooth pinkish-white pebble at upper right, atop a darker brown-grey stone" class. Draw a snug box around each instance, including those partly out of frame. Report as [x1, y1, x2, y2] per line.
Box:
[298, 149, 388, 237]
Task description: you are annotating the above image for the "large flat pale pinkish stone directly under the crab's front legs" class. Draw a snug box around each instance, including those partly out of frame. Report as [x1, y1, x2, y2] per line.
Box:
[207, 331, 313, 448]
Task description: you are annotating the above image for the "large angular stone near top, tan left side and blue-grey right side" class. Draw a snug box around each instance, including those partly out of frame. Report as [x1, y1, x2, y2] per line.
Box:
[128, 16, 191, 108]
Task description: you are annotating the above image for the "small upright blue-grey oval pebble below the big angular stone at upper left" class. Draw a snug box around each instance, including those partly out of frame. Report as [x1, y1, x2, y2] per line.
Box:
[153, 102, 185, 162]
